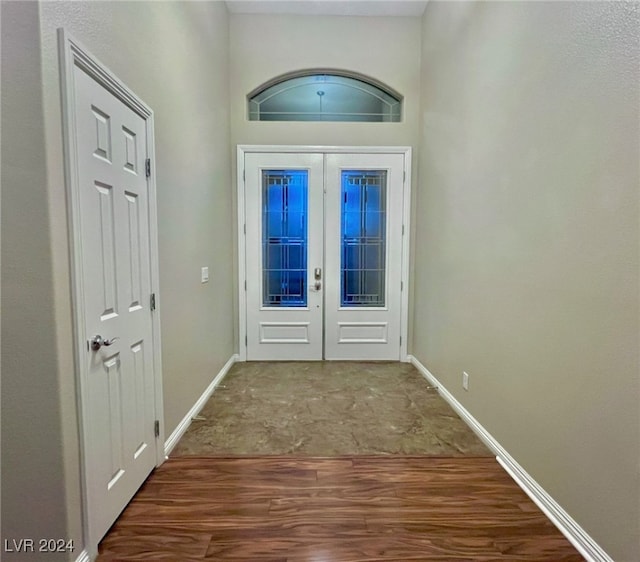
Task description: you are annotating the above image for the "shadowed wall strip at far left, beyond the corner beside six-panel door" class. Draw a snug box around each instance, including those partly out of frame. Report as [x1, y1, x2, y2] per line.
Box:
[0, 2, 70, 559]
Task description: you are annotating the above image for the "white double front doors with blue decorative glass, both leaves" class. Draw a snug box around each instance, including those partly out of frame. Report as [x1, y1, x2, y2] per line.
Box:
[244, 153, 405, 360]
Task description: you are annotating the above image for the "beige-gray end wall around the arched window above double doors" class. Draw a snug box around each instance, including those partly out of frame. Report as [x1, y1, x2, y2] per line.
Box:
[230, 14, 420, 146]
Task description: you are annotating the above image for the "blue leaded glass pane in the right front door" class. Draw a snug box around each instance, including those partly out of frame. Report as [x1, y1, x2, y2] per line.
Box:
[340, 170, 387, 307]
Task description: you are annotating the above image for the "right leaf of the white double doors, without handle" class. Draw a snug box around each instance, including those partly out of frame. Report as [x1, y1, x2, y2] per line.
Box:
[325, 154, 404, 360]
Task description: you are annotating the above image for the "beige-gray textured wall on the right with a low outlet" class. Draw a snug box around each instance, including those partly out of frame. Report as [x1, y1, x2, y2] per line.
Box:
[413, 2, 640, 562]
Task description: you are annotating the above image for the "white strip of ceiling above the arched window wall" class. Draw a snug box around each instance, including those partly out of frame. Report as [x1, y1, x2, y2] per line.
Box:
[226, 0, 428, 17]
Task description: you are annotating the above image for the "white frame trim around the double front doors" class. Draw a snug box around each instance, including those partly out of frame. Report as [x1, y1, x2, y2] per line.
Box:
[236, 144, 411, 362]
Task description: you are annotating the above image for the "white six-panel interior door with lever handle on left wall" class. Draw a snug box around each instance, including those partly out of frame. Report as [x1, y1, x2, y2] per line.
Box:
[70, 59, 156, 541]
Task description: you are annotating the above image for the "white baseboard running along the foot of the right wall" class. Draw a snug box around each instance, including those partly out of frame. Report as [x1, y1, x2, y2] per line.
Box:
[409, 355, 614, 562]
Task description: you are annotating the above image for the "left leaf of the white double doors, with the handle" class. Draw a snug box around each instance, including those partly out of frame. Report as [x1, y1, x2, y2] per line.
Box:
[245, 153, 323, 360]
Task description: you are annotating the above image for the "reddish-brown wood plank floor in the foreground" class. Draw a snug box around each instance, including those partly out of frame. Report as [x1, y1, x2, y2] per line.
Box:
[98, 456, 583, 562]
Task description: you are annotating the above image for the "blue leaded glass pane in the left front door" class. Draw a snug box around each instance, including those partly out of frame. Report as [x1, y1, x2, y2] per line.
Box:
[262, 170, 308, 307]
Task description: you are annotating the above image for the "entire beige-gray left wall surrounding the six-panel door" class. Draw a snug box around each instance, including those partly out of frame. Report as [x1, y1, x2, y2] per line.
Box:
[2, 1, 234, 560]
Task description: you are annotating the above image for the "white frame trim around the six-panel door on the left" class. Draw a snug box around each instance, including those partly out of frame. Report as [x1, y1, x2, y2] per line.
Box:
[58, 28, 166, 559]
